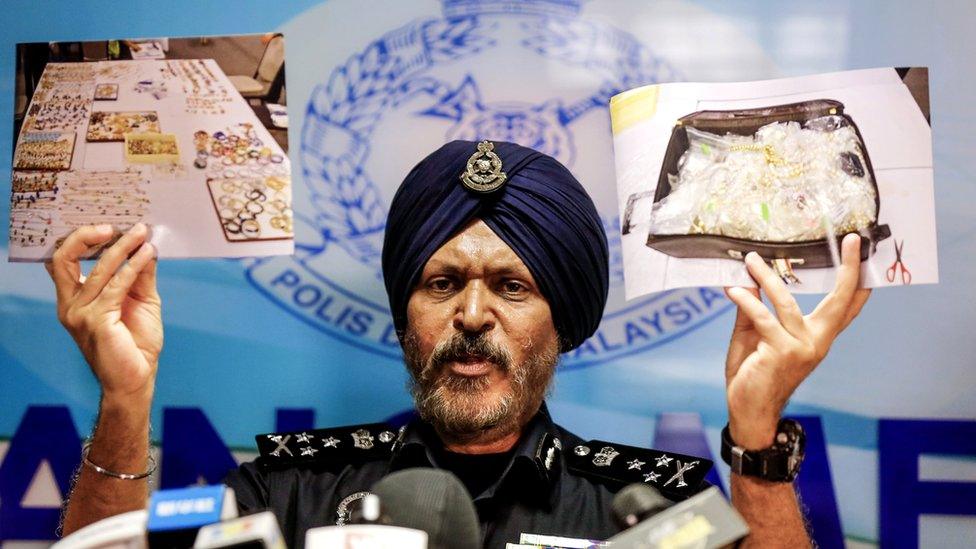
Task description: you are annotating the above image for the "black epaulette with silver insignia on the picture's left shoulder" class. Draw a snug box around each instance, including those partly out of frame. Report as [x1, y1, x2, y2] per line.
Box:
[254, 423, 397, 469]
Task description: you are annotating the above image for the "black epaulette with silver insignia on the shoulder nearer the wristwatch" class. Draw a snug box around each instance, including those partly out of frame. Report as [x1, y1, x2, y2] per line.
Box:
[566, 440, 712, 499]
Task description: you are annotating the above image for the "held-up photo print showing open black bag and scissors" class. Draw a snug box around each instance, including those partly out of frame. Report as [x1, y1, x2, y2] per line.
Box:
[611, 69, 938, 297]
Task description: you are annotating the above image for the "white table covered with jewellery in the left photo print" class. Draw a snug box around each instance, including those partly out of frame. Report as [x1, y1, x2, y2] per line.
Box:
[10, 59, 294, 261]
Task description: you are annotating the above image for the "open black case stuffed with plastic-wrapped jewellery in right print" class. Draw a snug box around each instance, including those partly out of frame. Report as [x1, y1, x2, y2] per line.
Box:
[623, 99, 891, 268]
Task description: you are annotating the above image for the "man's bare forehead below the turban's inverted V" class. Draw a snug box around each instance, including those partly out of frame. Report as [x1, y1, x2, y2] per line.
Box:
[425, 219, 531, 277]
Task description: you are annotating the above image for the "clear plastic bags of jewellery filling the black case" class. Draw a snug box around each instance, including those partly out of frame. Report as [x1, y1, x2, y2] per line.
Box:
[651, 116, 877, 242]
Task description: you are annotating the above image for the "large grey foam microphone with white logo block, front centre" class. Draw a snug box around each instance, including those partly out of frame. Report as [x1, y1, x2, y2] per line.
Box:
[305, 468, 481, 549]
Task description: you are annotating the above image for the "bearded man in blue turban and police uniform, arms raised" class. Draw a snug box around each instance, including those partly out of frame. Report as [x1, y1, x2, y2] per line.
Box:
[49, 141, 868, 547]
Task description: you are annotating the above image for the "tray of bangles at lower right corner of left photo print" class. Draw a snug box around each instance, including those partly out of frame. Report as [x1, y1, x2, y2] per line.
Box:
[207, 176, 294, 242]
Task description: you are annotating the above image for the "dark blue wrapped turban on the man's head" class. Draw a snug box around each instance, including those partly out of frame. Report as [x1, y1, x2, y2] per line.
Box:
[383, 141, 609, 352]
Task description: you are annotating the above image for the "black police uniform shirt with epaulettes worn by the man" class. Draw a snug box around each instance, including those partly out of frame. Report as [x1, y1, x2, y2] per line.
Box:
[224, 404, 712, 548]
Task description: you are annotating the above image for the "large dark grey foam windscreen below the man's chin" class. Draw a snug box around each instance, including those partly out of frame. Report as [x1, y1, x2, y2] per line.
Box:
[371, 468, 481, 549]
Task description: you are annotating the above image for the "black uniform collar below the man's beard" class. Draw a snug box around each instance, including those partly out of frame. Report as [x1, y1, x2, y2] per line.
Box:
[390, 402, 564, 506]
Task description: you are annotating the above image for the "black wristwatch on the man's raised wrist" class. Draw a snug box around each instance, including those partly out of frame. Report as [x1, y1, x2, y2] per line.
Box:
[722, 419, 806, 482]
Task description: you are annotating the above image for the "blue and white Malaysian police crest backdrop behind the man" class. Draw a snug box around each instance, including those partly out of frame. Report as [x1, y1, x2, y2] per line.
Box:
[0, 0, 976, 547]
